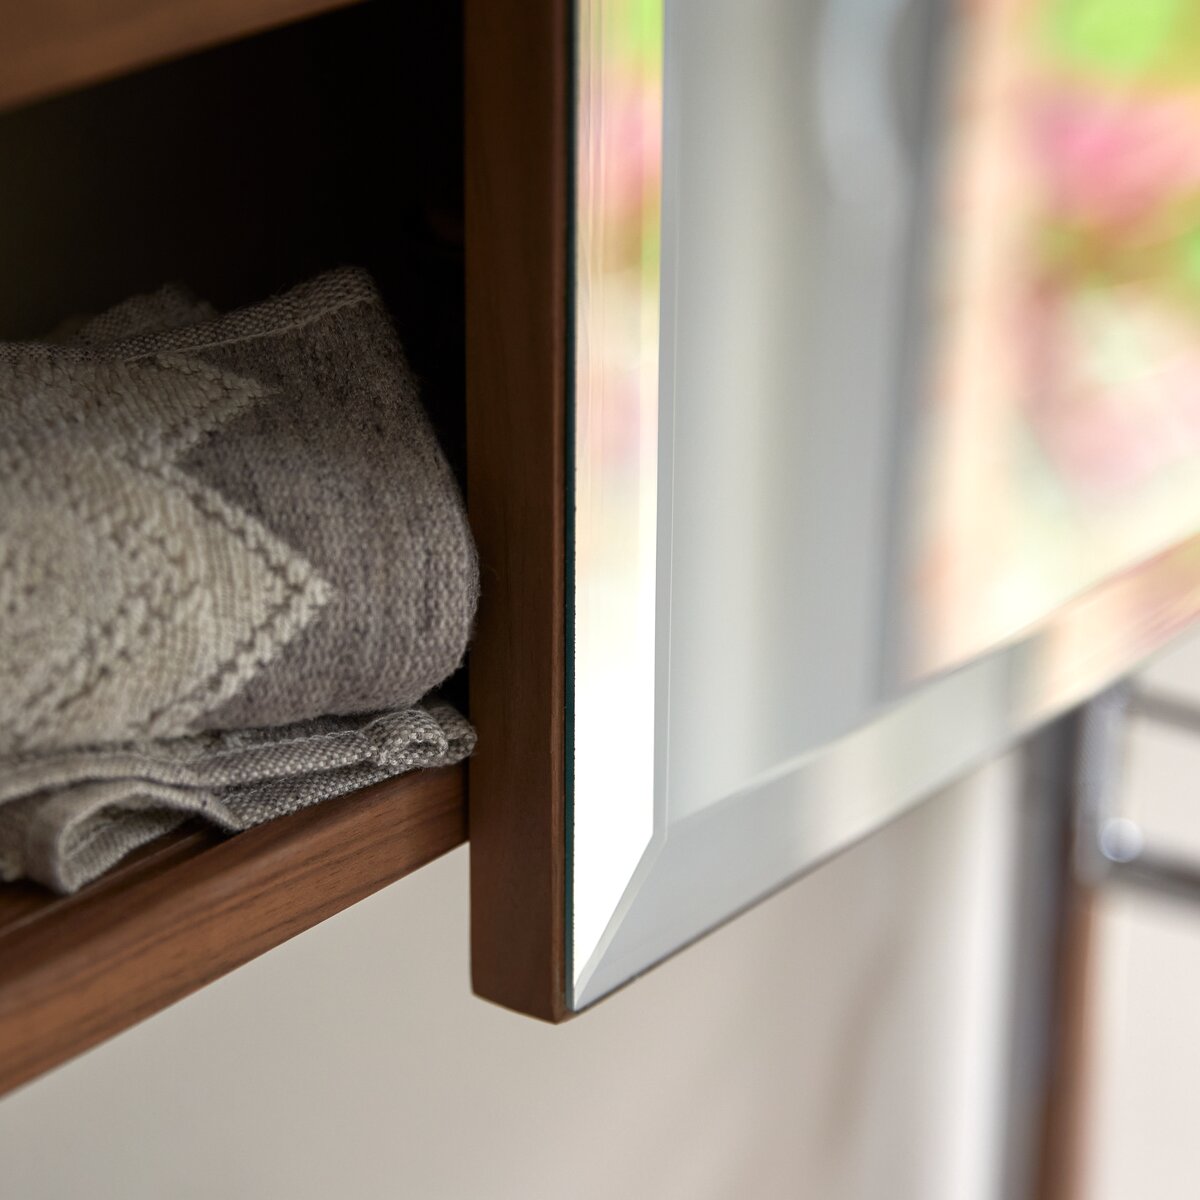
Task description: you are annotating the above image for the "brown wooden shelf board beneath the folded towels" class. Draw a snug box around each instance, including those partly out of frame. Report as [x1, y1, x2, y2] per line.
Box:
[0, 767, 467, 1094]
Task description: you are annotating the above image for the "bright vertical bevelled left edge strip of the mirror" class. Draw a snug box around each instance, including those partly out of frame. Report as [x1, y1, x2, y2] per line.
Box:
[566, 0, 670, 989]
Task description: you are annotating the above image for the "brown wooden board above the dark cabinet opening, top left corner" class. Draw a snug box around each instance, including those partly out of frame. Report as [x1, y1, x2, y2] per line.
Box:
[0, 0, 355, 108]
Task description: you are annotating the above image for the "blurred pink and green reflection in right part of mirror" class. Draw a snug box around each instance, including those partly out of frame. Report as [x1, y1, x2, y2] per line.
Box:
[904, 0, 1200, 701]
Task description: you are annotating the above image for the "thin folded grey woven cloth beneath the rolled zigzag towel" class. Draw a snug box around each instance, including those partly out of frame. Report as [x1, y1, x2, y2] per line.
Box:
[0, 700, 475, 892]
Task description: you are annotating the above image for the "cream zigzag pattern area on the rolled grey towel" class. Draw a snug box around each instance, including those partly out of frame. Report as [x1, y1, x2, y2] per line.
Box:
[0, 355, 331, 754]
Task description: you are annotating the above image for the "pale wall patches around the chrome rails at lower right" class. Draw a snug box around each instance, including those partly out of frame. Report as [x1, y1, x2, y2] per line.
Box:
[1082, 635, 1200, 1200]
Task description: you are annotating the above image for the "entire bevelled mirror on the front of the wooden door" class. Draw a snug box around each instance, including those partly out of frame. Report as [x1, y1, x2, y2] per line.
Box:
[566, 0, 1200, 1009]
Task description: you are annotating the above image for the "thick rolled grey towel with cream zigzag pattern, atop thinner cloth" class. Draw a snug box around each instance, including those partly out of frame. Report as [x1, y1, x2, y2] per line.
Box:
[0, 271, 478, 754]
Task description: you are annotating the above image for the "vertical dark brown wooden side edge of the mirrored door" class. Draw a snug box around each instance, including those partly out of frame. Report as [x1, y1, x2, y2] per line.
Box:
[466, 0, 570, 1020]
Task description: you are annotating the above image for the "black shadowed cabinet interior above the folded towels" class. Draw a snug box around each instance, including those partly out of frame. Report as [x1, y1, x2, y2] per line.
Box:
[0, 2, 464, 487]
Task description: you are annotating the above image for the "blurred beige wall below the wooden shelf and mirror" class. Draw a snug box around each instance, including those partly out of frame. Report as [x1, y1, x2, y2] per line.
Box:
[0, 763, 1015, 1200]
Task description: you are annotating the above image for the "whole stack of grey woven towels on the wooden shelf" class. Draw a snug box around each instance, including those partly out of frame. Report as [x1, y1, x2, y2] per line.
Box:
[0, 270, 478, 890]
